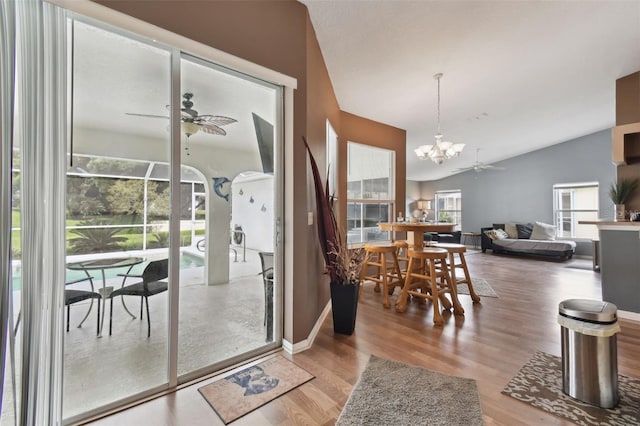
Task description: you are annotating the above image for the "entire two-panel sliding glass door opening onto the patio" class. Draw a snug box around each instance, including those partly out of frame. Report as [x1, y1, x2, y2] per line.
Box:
[58, 15, 282, 421]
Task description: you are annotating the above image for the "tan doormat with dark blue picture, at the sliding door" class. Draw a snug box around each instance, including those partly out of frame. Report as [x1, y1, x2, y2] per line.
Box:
[198, 355, 314, 424]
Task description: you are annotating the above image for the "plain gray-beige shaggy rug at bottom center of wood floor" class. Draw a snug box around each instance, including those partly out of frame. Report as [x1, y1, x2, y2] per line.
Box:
[336, 355, 483, 426]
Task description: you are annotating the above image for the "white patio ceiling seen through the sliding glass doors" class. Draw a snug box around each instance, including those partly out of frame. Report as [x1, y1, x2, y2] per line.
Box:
[73, 22, 277, 156]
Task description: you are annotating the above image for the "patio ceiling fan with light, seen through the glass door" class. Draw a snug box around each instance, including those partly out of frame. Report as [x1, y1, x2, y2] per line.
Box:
[126, 92, 238, 155]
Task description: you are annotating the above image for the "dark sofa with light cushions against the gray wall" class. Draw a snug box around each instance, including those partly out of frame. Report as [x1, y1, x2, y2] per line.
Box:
[480, 222, 576, 260]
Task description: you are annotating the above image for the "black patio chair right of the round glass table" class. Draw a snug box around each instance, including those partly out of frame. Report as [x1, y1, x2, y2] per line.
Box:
[109, 259, 169, 337]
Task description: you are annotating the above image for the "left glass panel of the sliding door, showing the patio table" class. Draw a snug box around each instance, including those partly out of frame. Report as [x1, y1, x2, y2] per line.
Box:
[63, 21, 171, 419]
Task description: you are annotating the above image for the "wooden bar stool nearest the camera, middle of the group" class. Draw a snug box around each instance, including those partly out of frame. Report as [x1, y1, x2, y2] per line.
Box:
[396, 247, 464, 326]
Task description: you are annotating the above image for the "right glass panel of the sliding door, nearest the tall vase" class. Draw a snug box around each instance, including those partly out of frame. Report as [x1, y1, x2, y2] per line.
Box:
[178, 56, 280, 380]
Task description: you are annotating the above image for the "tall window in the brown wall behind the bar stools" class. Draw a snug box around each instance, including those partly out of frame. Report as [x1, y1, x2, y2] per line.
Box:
[347, 142, 395, 243]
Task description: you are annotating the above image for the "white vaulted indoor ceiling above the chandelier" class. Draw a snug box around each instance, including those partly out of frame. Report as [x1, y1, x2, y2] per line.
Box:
[301, 0, 640, 181]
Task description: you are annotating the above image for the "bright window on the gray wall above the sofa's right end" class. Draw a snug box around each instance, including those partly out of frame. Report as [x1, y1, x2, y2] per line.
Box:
[553, 182, 599, 239]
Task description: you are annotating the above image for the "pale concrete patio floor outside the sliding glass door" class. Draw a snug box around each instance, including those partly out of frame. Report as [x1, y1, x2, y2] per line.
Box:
[8, 249, 266, 418]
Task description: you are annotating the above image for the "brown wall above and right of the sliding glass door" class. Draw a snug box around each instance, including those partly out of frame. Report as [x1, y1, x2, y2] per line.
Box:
[93, 0, 405, 343]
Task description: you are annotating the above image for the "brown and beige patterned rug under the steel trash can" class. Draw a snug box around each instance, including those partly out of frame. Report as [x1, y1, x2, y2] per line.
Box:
[502, 352, 640, 426]
